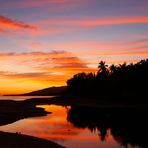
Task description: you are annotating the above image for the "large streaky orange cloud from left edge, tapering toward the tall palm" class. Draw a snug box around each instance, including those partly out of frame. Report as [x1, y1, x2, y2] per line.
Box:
[0, 51, 90, 73]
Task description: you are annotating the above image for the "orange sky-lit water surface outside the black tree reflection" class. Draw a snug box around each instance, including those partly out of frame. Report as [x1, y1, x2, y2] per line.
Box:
[0, 105, 119, 148]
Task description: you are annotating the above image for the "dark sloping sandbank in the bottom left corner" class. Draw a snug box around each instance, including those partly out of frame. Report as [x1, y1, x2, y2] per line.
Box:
[0, 132, 64, 148]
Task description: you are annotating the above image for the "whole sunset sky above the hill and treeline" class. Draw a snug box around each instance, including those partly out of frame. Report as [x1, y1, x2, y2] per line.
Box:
[0, 0, 148, 94]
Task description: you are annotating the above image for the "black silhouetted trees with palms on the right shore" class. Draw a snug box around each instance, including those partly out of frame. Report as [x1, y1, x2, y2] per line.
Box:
[67, 59, 148, 101]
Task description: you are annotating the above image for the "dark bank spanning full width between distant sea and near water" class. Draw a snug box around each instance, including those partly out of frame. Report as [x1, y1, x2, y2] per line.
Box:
[0, 97, 148, 126]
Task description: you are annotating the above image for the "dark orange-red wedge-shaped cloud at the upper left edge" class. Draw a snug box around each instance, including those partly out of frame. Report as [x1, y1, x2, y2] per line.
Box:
[0, 16, 35, 31]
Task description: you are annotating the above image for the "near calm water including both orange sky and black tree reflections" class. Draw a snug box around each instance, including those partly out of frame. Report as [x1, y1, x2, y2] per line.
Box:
[0, 97, 148, 148]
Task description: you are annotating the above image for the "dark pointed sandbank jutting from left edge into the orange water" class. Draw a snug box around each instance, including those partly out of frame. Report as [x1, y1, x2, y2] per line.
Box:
[0, 100, 50, 126]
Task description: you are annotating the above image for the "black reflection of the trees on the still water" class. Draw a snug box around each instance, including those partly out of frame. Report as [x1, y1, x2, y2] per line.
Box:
[67, 106, 148, 148]
